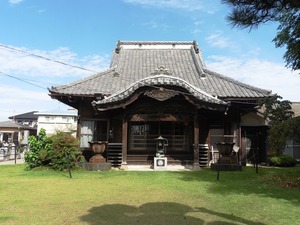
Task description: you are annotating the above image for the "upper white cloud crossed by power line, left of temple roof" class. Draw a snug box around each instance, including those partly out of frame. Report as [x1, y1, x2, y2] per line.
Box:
[0, 46, 109, 80]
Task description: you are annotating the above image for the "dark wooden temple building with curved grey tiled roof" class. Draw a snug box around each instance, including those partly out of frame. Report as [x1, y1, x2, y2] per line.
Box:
[49, 41, 271, 169]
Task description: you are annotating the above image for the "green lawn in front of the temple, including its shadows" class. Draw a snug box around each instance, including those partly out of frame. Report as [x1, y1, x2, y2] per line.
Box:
[0, 165, 300, 225]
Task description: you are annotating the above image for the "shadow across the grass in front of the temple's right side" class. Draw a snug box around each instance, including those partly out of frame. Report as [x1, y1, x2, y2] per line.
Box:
[173, 167, 300, 205]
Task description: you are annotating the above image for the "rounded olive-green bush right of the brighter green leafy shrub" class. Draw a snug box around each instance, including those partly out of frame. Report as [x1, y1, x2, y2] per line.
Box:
[50, 132, 83, 170]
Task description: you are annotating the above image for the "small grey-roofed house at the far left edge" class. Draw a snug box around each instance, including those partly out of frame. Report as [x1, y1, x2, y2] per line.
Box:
[0, 121, 36, 145]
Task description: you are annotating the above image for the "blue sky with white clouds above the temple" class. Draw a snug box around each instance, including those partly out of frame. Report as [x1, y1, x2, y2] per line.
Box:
[0, 0, 300, 121]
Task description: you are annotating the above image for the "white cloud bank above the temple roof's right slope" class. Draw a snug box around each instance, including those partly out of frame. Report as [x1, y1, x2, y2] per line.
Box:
[206, 55, 300, 102]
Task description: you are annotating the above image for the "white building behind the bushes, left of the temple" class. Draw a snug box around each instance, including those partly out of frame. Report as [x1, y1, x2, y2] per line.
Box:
[35, 110, 77, 135]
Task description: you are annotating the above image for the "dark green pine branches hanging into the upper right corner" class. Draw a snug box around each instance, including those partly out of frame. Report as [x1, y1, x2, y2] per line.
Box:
[222, 0, 300, 70]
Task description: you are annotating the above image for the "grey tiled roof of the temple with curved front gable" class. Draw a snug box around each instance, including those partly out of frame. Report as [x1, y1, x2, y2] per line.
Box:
[49, 41, 271, 106]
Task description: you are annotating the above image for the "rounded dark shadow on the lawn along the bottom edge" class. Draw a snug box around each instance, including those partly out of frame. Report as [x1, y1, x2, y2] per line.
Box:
[80, 202, 263, 225]
